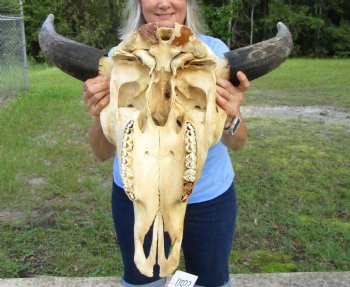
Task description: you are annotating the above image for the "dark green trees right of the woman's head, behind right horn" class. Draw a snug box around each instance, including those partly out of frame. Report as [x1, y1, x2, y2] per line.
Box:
[203, 0, 350, 57]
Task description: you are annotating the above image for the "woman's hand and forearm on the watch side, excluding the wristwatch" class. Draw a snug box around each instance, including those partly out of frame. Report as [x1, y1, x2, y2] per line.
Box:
[216, 72, 249, 150]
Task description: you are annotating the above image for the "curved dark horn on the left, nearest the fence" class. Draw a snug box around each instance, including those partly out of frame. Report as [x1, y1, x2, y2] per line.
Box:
[39, 14, 107, 81]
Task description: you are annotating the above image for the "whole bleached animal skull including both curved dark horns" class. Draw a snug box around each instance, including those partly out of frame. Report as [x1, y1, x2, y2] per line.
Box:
[39, 14, 293, 276]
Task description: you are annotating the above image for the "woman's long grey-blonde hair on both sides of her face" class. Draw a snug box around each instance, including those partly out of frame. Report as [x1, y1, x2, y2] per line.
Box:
[119, 0, 205, 40]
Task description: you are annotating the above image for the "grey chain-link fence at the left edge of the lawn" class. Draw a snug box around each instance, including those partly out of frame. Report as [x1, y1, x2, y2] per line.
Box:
[0, 1, 29, 101]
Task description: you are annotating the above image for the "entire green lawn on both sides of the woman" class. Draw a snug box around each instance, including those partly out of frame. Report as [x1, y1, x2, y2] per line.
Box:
[0, 59, 350, 277]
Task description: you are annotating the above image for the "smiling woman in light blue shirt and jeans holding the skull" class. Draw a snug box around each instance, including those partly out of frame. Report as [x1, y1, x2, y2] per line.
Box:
[84, 0, 249, 286]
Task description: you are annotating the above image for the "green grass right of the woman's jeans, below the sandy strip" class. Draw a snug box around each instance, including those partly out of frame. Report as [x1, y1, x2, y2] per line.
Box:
[232, 119, 350, 272]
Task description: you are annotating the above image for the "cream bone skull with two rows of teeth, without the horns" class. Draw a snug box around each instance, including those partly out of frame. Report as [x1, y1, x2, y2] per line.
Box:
[100, 24, 226, 277]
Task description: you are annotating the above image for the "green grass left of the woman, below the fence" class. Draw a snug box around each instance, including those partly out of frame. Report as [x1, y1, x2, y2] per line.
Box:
[0, 64, 122, 277]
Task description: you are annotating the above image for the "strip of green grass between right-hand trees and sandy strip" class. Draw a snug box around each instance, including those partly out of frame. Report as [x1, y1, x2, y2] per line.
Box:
[245, 59, 350, 110]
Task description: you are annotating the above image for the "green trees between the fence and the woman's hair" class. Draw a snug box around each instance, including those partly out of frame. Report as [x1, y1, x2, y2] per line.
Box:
[24, 0, 124, 59]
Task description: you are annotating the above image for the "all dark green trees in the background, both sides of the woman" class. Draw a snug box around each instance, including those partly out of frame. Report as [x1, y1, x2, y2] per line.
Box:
[18, 0, 350, 58]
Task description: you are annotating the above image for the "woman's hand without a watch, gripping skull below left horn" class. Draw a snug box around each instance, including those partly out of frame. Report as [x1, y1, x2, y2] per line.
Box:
[83, 76, 110, 117]
